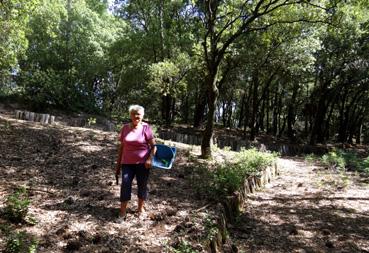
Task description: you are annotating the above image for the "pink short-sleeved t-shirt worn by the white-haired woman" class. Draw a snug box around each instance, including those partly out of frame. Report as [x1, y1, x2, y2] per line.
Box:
[119, 122, 154, 164]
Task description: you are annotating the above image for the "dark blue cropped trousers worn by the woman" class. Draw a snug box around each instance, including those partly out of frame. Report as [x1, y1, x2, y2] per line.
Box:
[120, 164, 150, 202]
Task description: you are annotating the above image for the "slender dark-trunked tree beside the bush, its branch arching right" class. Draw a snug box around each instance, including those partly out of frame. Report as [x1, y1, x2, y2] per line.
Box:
[196, 0, 329, 158]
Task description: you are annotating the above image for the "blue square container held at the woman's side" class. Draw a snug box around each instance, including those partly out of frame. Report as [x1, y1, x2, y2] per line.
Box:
[151, 144, 177, 170]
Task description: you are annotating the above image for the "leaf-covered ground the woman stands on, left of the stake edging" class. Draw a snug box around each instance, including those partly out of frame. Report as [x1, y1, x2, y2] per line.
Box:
[0, 114, 211, 252]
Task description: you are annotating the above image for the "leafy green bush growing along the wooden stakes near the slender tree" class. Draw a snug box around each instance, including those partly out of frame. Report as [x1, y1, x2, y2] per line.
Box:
[213, 149, 276, 195]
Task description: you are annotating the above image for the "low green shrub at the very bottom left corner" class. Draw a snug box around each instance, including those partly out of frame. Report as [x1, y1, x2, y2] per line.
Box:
[5, 231, 38, 253]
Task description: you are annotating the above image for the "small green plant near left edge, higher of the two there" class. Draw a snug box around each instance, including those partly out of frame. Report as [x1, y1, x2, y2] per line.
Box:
[4, 186, 31, 223]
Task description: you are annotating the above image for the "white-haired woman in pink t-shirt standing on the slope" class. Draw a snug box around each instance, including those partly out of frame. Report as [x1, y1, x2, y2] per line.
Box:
[116, 105, 156, 219]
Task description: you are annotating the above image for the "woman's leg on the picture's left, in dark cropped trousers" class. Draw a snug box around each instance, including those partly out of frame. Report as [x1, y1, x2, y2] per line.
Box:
[120, 165, 135, 216]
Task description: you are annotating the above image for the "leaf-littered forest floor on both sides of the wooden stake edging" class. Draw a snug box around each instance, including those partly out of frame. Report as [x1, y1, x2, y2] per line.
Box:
[0, 110, 369, 252]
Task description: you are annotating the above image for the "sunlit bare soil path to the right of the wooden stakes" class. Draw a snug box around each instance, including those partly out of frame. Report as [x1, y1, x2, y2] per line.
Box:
[230, 158, 369, 253]
